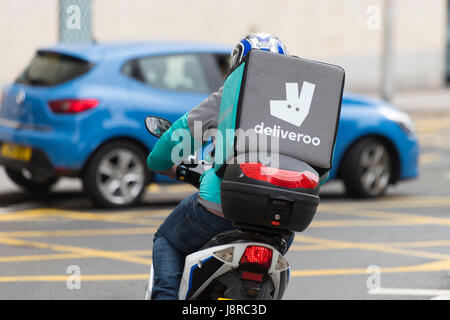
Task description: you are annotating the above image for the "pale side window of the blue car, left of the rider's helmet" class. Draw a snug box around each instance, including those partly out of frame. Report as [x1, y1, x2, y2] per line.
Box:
[137, 54, 210, 93]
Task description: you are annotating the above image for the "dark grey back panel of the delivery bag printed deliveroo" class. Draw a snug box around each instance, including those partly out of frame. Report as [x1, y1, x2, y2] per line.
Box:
[235, 50, 345, 170]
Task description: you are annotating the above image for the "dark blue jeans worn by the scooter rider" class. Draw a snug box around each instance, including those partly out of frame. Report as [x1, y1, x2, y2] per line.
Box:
[151, 193, 294, 300]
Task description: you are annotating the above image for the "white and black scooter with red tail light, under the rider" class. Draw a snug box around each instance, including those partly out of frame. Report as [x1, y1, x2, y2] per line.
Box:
[145, 117, 318, 300]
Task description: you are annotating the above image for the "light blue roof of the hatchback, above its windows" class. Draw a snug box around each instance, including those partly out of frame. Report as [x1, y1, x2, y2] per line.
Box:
[38, 41, 232, 62]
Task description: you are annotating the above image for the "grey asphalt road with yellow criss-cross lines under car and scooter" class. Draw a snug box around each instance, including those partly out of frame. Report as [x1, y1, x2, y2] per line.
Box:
[0, 113, 450, 299]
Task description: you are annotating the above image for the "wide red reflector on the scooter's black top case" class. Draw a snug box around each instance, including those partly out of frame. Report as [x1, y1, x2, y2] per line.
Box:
[240, 162, 319, 189]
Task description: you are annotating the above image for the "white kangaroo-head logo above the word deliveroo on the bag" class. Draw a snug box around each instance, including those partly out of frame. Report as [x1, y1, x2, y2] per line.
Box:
[270, 81, 316, 127]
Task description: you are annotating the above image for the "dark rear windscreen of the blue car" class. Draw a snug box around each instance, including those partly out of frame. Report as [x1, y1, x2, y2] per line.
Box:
[16, 51, 92, 87]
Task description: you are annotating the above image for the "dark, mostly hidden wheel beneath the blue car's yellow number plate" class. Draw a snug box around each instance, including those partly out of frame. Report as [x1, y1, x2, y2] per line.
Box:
[5, 168, 59, 191]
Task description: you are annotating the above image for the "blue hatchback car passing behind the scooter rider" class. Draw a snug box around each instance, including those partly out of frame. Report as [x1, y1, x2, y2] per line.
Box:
[0, 42, 419, 207]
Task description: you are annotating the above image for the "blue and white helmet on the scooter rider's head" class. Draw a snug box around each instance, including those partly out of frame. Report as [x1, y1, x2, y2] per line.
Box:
[230, 33, 288, 70]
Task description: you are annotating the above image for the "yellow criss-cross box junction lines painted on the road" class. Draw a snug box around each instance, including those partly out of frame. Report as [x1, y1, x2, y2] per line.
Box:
[0, 192, 450, 282]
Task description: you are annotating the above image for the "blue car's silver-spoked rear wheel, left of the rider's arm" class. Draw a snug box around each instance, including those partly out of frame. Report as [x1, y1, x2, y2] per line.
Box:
[82, 140, 150, 208]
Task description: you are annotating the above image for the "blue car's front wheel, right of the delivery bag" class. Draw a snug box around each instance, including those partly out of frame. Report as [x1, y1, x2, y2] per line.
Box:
[341, 138, 392, 198]
